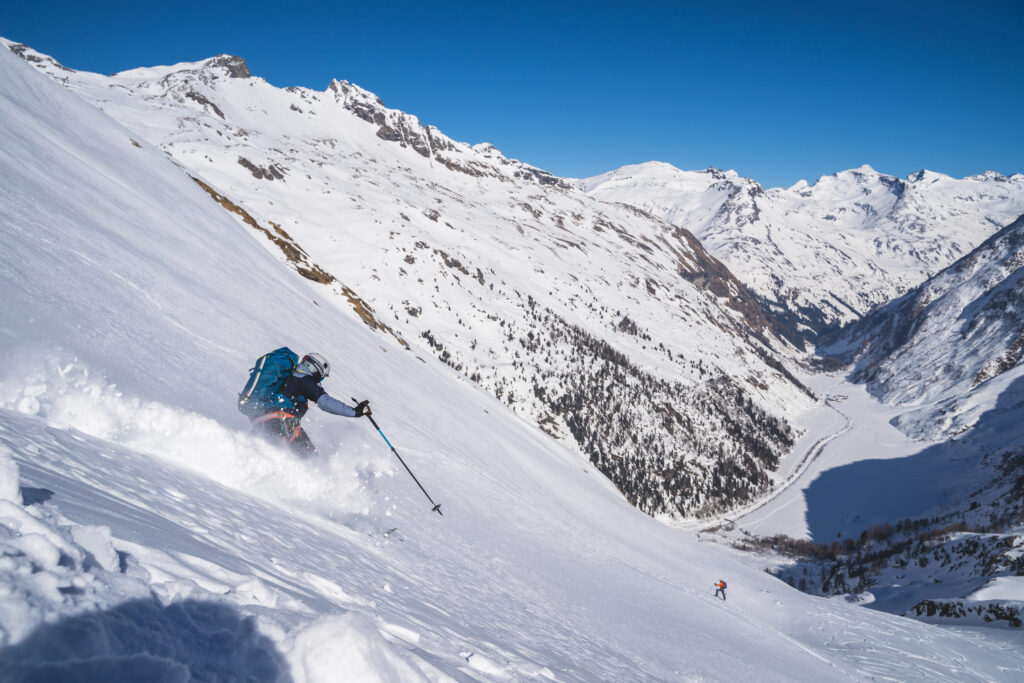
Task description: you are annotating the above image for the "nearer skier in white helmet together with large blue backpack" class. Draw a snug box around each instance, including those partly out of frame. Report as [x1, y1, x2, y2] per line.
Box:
[239, 348, 371, 456]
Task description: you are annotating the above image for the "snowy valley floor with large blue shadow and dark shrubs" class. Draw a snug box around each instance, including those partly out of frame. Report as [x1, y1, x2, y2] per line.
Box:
[696, 374, 1024, 651]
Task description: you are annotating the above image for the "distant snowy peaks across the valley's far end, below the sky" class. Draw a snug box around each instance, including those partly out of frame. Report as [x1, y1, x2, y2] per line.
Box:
[579, 162, 1024, 340]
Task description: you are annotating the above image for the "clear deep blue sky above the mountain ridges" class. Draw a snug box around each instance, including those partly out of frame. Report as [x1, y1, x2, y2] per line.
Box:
[0, 0, 1024, 186]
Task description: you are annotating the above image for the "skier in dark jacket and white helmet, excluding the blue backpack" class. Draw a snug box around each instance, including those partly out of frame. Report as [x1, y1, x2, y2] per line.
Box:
[253, 353, 371, 456]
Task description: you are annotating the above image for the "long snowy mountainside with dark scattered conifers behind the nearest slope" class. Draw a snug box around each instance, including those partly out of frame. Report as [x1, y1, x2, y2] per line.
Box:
[4, 45, 810, 517]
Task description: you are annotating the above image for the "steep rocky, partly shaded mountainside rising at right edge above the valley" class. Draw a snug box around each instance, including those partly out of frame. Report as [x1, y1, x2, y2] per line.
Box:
[820, 210, 1024, 437]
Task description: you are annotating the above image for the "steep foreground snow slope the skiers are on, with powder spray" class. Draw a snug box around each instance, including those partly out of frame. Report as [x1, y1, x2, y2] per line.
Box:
[0, 45, 1024, 682]
